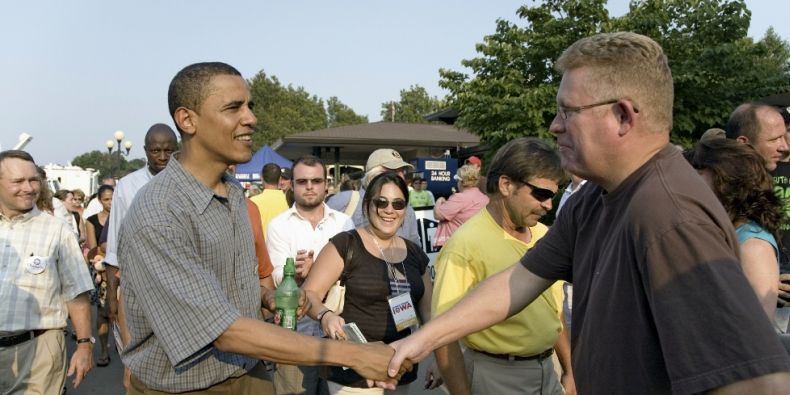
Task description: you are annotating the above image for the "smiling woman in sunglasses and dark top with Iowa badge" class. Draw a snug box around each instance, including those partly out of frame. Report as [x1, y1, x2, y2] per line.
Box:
[303, 171, 438, 394]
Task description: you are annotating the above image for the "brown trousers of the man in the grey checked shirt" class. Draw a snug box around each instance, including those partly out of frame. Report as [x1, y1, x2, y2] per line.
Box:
[126, 363, 274, 395]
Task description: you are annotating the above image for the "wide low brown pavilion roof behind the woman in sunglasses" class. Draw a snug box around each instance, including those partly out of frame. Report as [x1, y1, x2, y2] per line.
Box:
[272, 122, 480, 165]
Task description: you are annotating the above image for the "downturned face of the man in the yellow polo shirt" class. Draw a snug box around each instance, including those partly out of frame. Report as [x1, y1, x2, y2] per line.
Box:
[504, 178, 559, 228]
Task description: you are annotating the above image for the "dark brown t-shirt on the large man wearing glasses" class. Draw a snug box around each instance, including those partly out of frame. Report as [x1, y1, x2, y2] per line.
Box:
[521, 146, 790, 394]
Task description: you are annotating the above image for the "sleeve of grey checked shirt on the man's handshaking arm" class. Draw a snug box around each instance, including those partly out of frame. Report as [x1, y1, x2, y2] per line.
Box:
[119, 225, 242, 368]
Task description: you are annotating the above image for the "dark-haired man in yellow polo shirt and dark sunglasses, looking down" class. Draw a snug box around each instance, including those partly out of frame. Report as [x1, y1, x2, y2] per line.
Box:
[432, 138, 575, 395]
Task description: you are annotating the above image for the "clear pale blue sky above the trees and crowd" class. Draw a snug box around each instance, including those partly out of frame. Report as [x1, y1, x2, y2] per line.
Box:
[0, 0, 790, 164]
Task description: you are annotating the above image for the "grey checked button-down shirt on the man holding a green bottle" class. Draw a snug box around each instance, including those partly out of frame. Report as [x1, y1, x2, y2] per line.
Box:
[118, 156, 261, 392]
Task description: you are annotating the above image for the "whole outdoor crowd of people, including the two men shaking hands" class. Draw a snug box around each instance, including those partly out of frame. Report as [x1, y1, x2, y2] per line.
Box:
[0, 32, 790, 395]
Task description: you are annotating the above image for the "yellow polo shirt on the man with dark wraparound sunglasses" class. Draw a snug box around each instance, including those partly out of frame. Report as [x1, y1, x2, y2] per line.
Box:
[431, 208, 562, 356]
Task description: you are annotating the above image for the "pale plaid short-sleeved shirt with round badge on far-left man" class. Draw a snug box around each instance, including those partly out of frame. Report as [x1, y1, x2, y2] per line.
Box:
[0, 207, 93, 334]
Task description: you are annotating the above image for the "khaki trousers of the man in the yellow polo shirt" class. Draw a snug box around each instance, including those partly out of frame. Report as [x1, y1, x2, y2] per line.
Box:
[464, 349, 565, 395]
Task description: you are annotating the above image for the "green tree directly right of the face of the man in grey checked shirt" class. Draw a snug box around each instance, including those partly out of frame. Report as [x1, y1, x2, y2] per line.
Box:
[249, 70, 327, 149]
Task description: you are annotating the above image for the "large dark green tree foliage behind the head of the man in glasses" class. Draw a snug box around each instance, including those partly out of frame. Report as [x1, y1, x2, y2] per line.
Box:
[439, 0, 790, 147]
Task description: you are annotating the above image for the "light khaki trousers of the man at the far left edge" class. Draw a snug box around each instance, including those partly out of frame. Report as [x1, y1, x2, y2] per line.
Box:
[0, 329, 66, 395]
